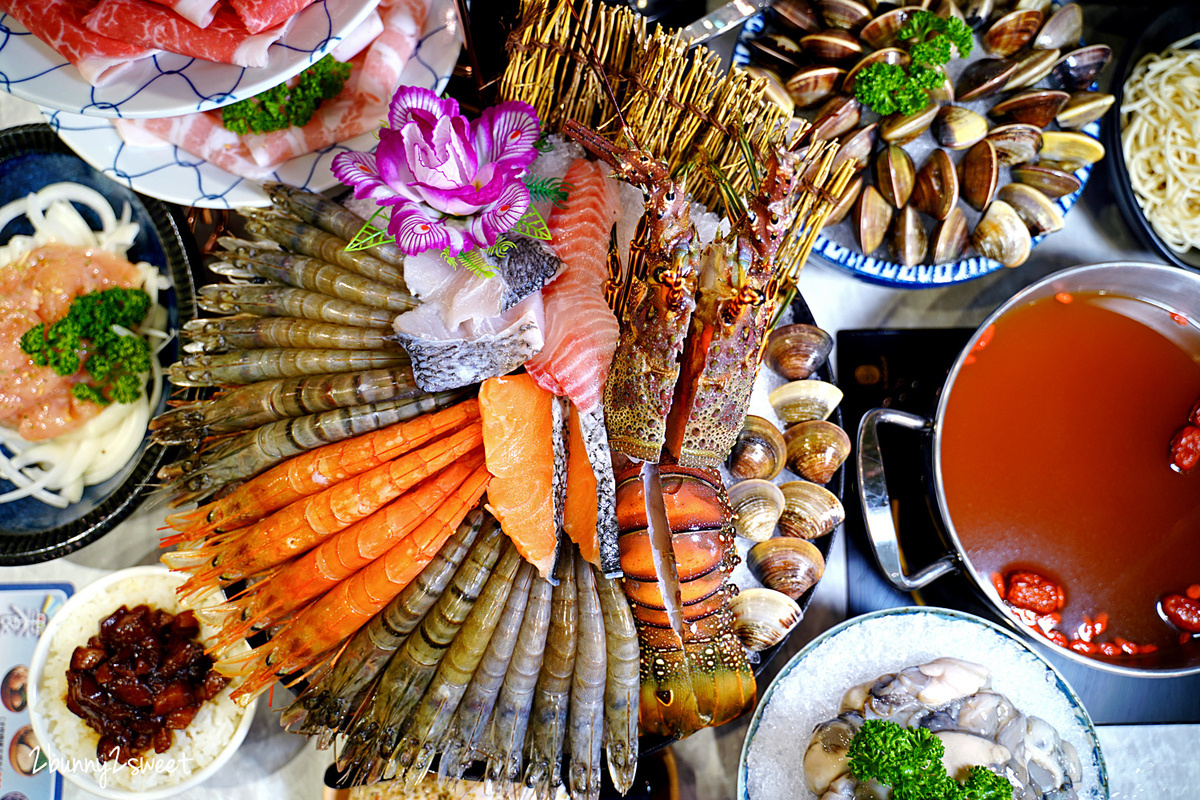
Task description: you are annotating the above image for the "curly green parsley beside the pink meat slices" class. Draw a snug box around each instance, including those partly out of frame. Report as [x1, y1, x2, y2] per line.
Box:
[221, 55, 350, 134]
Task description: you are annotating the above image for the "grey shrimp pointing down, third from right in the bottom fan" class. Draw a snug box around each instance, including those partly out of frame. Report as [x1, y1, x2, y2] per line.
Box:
[524, 542, 578, 800]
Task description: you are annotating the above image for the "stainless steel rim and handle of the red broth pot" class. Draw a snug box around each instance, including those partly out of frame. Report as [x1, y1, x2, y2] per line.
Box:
[857, 261, 1200, 678]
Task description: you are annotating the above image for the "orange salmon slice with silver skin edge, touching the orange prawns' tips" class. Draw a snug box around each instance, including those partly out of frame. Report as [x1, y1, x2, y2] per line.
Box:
[479, 374, 565, 579]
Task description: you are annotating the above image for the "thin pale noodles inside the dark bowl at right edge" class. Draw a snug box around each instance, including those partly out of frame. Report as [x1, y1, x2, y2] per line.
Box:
[1121, 34, 1200, 253]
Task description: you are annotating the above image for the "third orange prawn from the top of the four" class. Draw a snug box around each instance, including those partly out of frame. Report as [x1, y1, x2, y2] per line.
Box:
[196, 450, 484, 637]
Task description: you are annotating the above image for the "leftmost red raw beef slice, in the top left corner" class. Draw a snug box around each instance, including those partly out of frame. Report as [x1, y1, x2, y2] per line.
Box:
[0, 0, 156, 86]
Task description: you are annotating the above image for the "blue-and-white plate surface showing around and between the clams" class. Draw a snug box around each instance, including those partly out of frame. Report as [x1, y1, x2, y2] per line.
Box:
[732, 0, 1099, 289]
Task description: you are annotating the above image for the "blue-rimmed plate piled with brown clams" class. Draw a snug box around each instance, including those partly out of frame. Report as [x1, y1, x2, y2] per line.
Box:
[733, 0, 1112, 288]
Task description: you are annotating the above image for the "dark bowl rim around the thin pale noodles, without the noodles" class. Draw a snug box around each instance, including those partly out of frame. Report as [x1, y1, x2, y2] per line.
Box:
[1104, 0, 1200, 270]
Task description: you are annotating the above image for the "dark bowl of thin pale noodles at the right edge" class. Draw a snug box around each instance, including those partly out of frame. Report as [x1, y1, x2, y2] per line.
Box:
[1104, 1, 1200, 270]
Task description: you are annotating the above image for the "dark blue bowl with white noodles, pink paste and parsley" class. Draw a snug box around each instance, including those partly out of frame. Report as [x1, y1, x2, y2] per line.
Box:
[0, 126, 193, 565]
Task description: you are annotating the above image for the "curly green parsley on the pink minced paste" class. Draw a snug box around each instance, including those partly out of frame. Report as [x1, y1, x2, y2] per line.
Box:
[20, 289, 151, 405]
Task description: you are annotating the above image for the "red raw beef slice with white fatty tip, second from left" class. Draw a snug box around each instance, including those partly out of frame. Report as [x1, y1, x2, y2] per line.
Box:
[84, 0, 287, 67]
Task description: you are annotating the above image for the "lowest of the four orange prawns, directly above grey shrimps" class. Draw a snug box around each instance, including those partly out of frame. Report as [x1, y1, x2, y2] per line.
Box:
[215, 467, 492, 704]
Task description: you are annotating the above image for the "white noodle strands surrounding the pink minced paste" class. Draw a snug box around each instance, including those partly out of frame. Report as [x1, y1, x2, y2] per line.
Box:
[0, 184, 173, 509]
